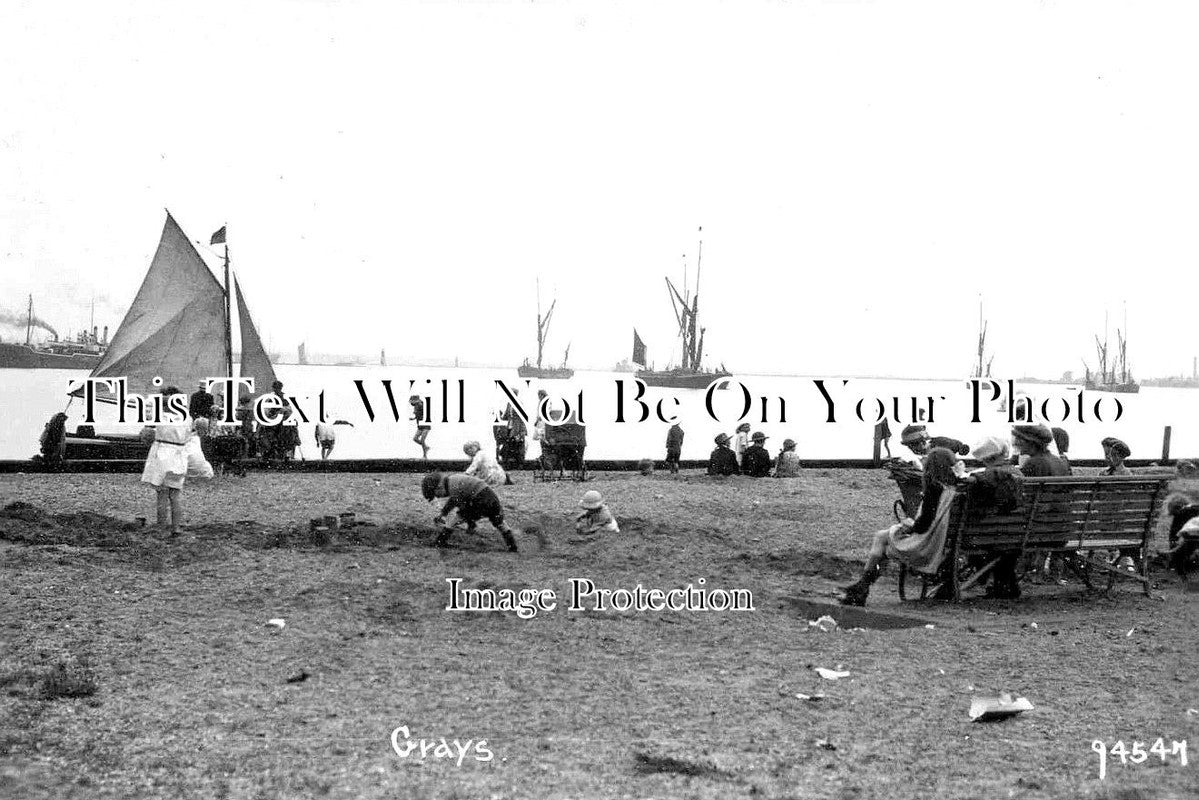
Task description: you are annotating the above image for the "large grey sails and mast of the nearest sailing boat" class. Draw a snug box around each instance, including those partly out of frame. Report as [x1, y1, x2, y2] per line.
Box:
[72, 211, 276, 402]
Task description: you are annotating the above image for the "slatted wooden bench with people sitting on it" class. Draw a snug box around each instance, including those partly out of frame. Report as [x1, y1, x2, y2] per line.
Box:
[899, 475, 1170, 601]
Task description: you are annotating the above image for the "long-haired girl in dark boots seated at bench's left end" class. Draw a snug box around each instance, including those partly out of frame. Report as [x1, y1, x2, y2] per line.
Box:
[840, 447, 959, 606]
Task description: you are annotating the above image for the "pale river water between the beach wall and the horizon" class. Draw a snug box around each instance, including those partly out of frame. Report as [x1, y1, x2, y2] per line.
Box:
[0, 365, 1199, 459]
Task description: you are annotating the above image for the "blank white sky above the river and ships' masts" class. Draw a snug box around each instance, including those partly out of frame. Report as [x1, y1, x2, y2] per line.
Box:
[0, 0, 1199, 378]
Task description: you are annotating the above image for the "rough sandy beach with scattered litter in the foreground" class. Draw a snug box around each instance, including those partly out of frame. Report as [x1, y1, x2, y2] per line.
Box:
[0, 470, 1199, 799]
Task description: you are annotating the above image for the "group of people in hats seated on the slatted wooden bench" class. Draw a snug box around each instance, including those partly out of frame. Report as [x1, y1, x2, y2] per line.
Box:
[842, 425, 1146, 606]
